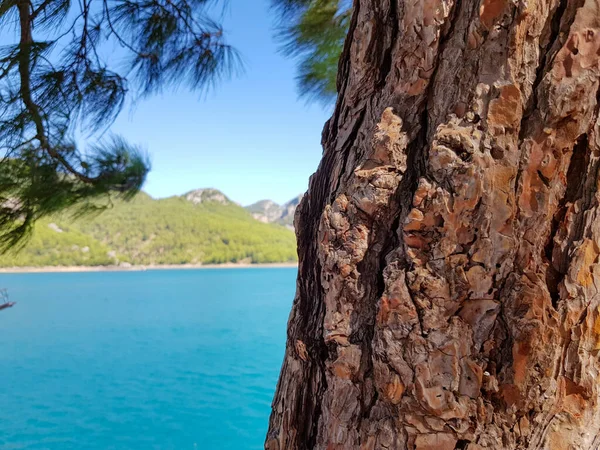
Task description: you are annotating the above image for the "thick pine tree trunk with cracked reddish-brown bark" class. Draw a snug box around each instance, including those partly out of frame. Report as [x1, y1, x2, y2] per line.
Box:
[265, 0, 600, 450]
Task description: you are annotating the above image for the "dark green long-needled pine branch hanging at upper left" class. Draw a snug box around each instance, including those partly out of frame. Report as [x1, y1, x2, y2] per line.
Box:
[0, 0, 238, 252]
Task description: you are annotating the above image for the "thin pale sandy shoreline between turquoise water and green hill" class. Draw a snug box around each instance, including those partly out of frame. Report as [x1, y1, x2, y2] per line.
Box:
[0, 263, 298, 274]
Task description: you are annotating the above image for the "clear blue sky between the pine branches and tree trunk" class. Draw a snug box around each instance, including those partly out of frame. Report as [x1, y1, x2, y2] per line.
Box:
[106, 0, 330, 205]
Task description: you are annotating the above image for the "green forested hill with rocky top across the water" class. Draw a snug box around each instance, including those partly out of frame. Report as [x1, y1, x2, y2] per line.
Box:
[0, 190, 297, 267]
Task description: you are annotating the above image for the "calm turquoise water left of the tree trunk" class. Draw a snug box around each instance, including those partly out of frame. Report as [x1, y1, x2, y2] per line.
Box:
[0, 269, 296, 450]
